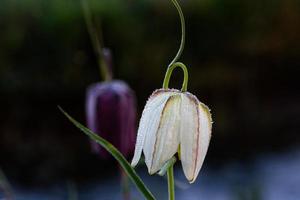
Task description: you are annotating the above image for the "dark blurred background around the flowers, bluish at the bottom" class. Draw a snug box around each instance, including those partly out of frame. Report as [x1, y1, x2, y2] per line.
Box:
[0, 0, 300, 200]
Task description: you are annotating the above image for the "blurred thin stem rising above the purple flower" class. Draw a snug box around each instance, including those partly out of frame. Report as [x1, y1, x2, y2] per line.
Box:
[81, 0, 112, 81]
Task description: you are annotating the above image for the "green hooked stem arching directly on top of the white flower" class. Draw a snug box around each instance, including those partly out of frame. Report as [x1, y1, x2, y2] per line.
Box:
[163, 62, 189, 92]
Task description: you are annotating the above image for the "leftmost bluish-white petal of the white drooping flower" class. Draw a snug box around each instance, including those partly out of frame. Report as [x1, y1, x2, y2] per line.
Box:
[131, 91, 170, 166]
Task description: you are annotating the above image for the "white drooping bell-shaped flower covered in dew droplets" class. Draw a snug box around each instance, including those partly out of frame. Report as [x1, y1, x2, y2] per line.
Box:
[131, 89, 212, 183]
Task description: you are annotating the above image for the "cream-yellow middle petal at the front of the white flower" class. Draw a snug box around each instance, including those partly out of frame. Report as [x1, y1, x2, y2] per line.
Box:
[149, 94, 181, 174]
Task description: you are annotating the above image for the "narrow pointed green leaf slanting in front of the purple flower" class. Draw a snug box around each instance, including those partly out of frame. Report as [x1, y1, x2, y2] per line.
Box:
[58, 107, 155, 200]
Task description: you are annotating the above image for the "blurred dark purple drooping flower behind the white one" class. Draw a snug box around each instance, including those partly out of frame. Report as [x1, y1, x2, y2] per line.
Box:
[86, 81, 136, 158]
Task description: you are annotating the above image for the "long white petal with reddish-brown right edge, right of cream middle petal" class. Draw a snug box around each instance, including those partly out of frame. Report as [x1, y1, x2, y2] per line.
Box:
[180, 93, 199, 182]
